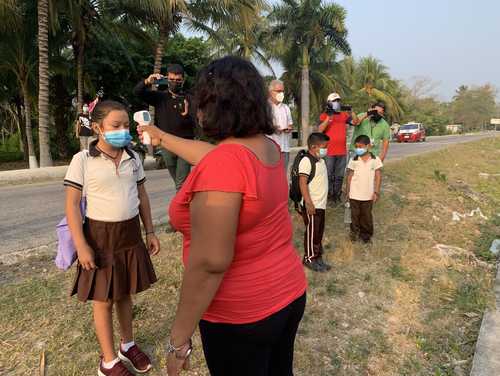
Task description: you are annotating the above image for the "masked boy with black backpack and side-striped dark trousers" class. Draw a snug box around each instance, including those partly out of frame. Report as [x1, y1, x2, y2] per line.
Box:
[299, 133, 331, 272]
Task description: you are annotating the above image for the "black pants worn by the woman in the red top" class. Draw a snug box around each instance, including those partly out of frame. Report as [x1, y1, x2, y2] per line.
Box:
[200, 293, 306, 376]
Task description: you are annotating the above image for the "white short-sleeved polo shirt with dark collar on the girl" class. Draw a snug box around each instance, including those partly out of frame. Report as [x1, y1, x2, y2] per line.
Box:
[64, 142, 146, 222]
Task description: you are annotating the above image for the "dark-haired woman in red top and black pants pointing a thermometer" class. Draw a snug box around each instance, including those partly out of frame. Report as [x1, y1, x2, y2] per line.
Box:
[139, 57, 306, 376]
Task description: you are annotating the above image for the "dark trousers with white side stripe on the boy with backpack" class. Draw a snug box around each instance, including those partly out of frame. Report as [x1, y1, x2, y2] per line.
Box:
[302, 208, 325, 262]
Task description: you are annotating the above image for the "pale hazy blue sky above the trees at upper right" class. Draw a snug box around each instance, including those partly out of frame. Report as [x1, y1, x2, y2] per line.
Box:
[308, 0, 500, 99]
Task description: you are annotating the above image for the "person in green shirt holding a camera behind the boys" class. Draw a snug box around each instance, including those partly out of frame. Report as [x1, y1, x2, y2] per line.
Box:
[350, 102, 391, 162]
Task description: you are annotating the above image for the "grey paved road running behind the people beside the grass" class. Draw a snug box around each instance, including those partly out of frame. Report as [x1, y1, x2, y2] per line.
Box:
[0, 134, 494, 254]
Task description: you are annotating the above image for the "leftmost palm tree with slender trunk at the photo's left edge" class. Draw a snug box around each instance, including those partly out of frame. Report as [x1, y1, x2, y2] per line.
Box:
[0, 1, 38, 168]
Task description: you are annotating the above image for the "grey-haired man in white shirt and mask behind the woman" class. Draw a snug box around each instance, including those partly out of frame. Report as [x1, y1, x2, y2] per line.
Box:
[269, 80, 293, 172]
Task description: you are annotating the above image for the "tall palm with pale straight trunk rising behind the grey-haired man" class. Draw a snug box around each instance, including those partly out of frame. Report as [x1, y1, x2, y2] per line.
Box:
[270, 0, 351, 144]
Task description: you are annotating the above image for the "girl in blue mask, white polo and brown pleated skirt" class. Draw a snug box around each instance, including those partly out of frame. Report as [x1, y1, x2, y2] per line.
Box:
[64, 101, 160, 376]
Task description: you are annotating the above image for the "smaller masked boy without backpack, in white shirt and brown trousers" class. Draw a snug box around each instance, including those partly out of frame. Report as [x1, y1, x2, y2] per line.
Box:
[346, 135, 383, 243]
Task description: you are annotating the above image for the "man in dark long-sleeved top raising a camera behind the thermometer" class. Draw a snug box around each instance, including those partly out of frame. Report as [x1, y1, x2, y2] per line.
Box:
[134, 64, 196, 190]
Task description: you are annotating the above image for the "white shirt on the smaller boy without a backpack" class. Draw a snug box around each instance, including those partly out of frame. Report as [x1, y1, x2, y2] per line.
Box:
[347, 157, 384, 201]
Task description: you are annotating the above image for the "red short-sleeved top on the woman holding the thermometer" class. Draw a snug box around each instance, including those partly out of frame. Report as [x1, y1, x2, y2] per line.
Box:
[170, 144, 307, 324]
